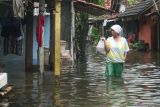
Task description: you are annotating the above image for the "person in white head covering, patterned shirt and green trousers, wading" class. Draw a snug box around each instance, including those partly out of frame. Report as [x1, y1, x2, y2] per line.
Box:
[102, 24, 129, 78]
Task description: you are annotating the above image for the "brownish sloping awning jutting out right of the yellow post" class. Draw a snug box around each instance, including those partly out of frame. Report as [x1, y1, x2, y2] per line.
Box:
[74, 0, 113, 16]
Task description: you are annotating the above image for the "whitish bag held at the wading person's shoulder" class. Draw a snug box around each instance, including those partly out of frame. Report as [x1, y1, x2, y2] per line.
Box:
[96, 39, 106, 55]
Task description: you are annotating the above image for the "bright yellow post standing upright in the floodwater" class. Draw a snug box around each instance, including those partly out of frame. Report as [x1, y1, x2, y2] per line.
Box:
[50, 0, 61, 76]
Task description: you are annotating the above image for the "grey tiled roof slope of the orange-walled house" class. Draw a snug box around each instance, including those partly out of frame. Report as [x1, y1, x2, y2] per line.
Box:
[119, 0, 154, 17]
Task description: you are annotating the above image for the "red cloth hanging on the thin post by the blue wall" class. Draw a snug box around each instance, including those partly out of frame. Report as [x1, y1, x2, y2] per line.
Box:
[36, 15, 44, 47]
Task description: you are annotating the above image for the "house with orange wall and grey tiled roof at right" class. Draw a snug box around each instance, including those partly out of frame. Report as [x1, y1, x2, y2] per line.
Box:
[118, 0, 160, 51]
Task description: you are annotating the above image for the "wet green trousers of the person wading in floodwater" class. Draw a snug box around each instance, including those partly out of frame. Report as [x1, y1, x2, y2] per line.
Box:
[105, 62, 123, 77]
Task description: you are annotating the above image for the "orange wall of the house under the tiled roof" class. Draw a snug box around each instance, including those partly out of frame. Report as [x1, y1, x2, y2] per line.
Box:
[139, 17, 151, 50]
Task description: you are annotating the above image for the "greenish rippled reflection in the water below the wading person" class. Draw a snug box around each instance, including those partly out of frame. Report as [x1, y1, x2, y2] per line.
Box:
[106, 78, 129, 107]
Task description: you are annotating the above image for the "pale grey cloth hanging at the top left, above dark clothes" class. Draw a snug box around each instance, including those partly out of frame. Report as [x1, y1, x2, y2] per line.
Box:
[13, 0, 24, 18]
